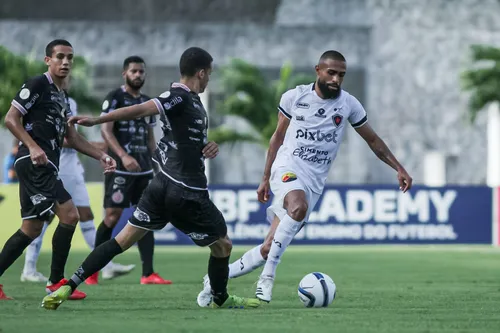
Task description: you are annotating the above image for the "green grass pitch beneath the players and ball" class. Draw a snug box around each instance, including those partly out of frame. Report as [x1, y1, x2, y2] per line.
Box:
[0, 245, 500, 333]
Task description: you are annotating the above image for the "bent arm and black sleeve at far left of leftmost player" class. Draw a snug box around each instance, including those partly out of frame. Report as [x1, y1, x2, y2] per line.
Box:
[5, 78, 48, 165]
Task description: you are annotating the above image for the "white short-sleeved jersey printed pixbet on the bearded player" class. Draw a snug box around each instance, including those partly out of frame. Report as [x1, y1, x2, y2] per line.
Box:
[272, 83, 367, 194]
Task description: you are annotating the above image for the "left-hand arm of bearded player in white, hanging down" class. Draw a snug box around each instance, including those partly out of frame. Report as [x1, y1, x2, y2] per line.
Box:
[257, 90, 295, 203]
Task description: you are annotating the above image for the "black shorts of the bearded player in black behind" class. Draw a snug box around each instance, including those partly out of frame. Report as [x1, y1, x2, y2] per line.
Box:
[104, 173, 153, 208]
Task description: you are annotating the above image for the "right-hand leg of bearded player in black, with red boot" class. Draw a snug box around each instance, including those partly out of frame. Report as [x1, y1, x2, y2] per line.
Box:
[131, 174, 172, 284]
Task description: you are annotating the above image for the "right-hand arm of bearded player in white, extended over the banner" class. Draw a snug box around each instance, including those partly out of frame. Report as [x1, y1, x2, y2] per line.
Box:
[349, 96, 413, 192]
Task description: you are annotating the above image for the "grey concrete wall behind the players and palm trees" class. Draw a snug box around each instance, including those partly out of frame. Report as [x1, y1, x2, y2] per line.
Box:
[0, 0, 500, 184]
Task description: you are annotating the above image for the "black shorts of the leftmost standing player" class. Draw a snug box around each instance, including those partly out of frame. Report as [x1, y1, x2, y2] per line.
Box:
[14, 155, 71, 220]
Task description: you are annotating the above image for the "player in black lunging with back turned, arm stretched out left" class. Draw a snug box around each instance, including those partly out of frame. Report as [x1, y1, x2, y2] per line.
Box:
[42, 47, 260, 310]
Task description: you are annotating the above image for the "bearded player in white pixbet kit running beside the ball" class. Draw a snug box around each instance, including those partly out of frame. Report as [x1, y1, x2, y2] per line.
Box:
[198, 51, 412, 306]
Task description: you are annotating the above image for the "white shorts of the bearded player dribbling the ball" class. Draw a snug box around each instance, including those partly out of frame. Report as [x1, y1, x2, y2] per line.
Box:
[266, 167, 321, 223]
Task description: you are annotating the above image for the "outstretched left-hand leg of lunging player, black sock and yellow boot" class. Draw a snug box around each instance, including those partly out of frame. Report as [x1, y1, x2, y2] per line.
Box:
[42, 224, 147, 310]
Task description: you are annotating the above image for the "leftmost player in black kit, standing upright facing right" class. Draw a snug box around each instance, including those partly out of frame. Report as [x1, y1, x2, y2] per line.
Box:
[0, 39, 116, 299]
